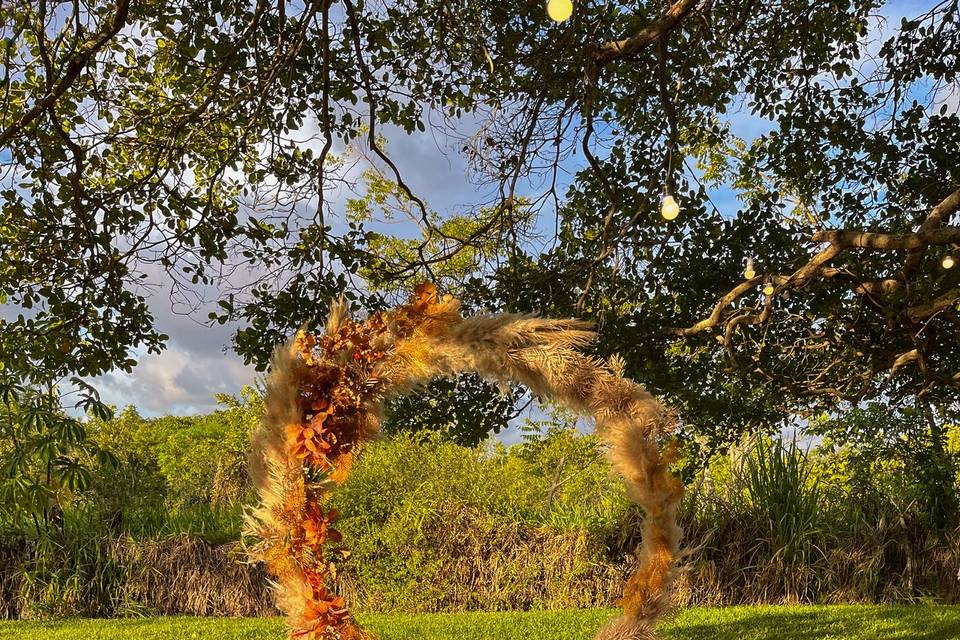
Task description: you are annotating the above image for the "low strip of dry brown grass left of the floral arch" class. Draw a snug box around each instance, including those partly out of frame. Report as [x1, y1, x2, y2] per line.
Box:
[0, 530, 276, 620]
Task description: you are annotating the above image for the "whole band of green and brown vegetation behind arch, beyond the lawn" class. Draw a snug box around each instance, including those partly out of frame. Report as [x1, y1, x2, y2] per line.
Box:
[0, 389, 960, 619]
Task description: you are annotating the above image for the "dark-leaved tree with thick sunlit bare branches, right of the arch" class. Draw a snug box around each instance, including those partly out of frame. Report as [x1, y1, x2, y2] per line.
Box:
[460, 2, 960, 437]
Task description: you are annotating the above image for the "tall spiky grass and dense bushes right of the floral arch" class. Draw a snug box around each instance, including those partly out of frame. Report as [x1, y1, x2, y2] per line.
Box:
[682, 428, 960, 604]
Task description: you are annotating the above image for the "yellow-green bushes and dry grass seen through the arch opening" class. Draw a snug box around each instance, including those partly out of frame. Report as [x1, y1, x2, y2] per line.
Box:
[333, 430, 629, 611]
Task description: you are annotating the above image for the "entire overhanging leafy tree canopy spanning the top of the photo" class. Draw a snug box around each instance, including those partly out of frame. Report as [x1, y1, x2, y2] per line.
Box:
[0, 0, 960, 450]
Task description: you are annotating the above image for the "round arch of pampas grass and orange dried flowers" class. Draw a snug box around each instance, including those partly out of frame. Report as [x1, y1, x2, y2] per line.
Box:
[247, 284, 683, 640]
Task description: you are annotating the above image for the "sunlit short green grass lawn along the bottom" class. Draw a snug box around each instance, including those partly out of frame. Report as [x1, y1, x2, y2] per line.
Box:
[0, 606, 960, 640]
